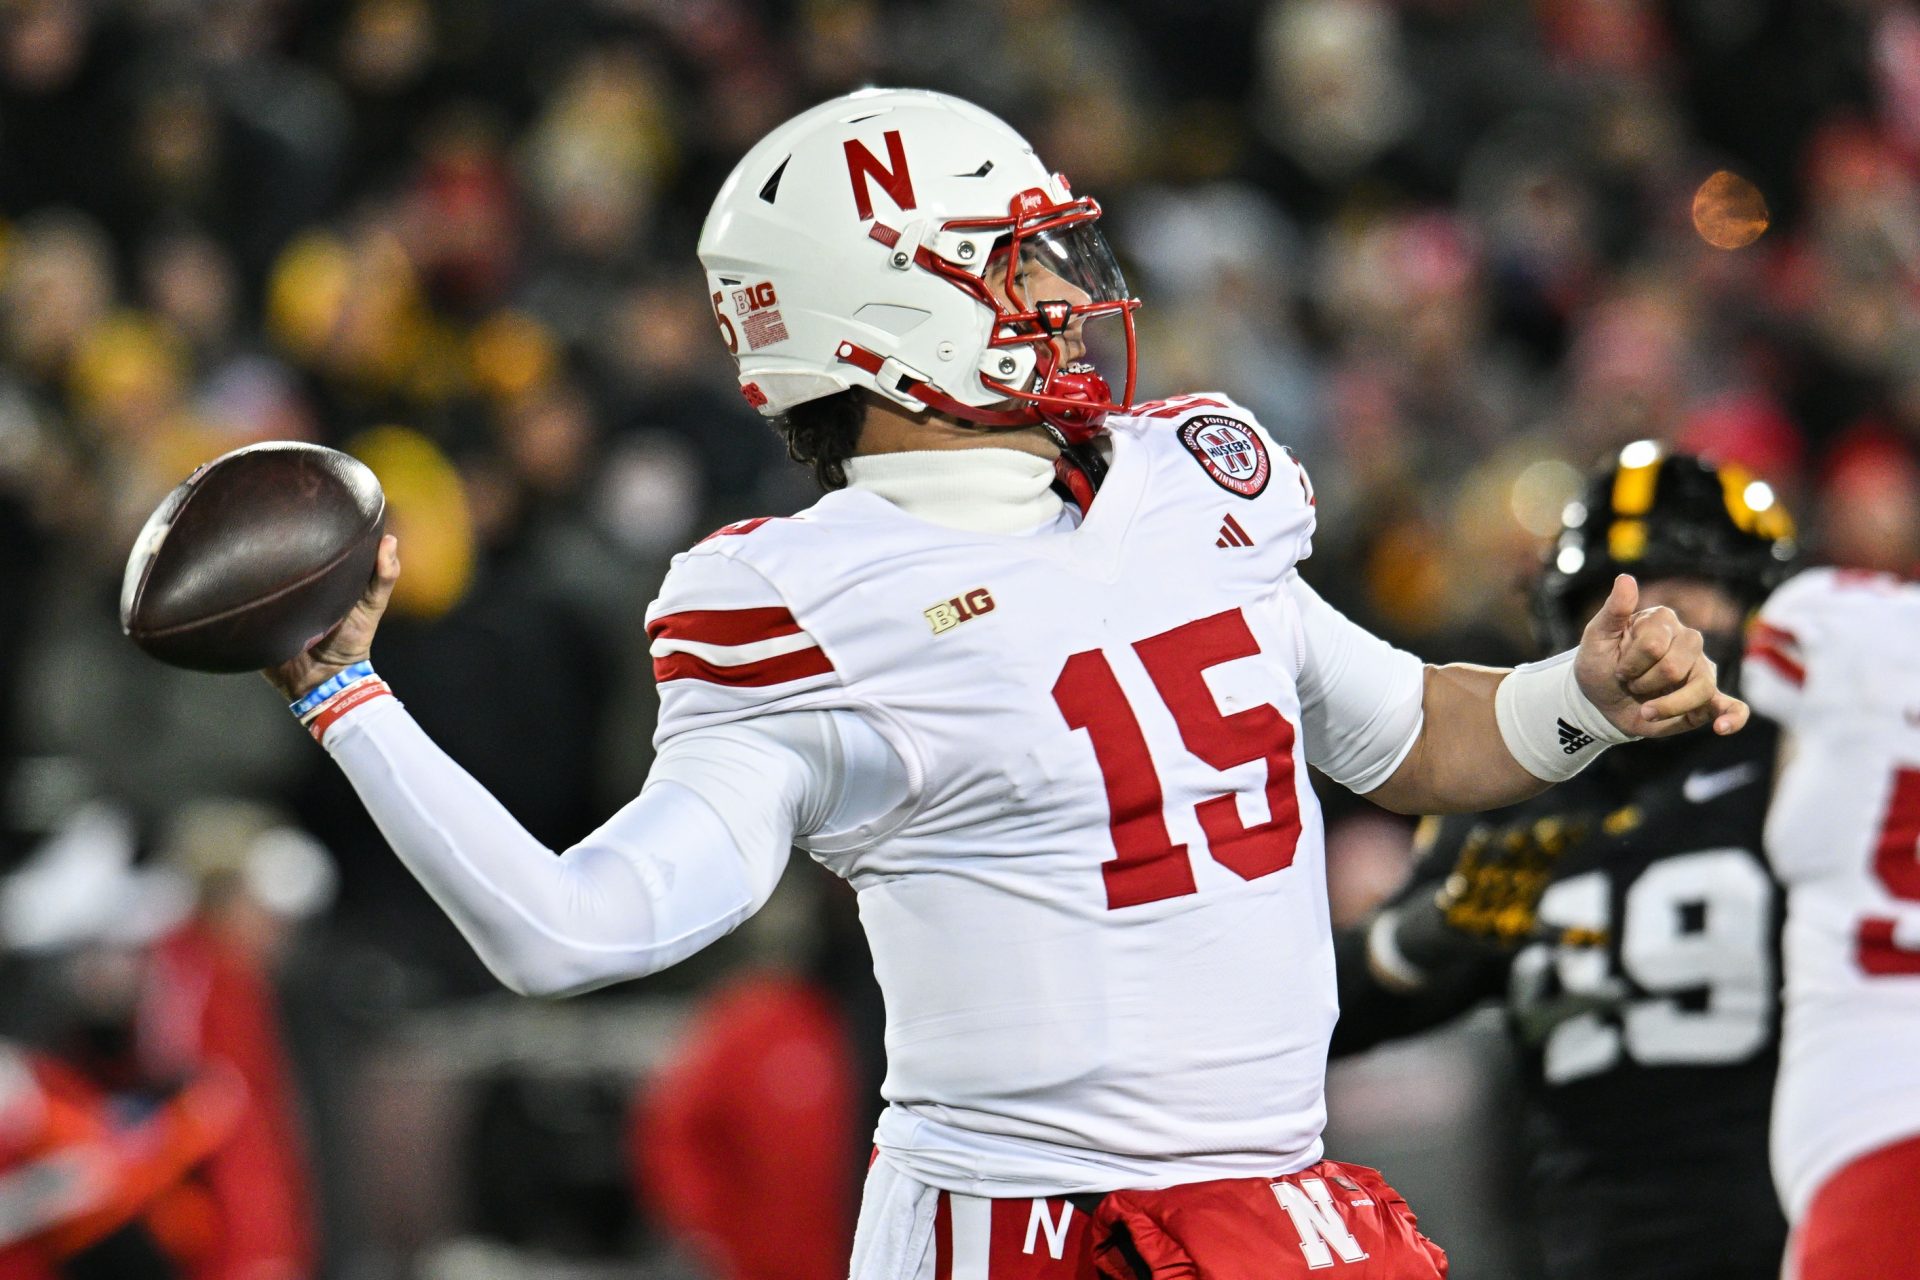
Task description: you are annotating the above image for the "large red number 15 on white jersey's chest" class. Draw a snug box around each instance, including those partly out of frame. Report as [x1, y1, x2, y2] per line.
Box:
[1054, 608, 1300, 910]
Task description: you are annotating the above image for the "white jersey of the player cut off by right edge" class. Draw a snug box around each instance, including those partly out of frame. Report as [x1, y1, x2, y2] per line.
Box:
[1741, 570, 1920, 1219]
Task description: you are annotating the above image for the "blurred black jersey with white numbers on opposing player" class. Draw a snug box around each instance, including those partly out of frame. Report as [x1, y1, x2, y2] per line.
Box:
[1332, 722, 1786, 1280]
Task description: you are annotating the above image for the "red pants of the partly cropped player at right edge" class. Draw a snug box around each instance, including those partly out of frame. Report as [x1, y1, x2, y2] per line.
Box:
[1788, 1138, 1920, 1280]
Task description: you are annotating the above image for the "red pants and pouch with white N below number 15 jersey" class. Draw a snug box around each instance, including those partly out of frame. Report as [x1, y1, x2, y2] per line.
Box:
[933, 1161, 1446, 1280]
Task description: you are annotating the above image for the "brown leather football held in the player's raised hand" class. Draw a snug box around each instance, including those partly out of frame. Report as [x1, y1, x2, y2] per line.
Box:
[121, 441, 386, 672]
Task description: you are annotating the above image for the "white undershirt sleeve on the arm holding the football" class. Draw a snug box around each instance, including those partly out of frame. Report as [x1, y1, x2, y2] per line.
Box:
[326, 699, 904, 996]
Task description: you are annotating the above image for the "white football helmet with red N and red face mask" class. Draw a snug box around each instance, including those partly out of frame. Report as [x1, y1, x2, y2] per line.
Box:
[699, 88, 1139, 443]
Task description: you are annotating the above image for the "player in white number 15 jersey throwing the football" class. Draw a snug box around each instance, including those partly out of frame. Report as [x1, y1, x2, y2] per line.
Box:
[271, 90, 1747, 1280]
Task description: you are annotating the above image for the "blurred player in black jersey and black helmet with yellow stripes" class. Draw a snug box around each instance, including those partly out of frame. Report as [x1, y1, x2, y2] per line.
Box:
[1332, 441, 1793, 1280]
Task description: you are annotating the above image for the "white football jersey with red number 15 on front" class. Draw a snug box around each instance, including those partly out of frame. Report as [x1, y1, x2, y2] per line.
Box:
[649, 397, 1351, 1196]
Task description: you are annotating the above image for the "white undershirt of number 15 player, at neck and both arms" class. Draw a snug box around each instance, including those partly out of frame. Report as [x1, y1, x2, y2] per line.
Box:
[326, 449, 1421, 996]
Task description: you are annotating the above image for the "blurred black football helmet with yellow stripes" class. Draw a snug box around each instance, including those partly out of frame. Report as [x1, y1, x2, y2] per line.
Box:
[1532, 439, 1797, 689]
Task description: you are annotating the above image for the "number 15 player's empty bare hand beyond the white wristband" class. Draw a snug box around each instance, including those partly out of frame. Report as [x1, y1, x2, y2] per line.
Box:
[1574, 574, 1747, 737]
